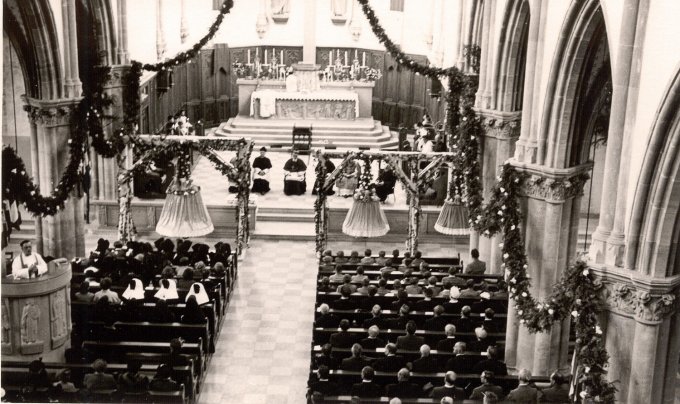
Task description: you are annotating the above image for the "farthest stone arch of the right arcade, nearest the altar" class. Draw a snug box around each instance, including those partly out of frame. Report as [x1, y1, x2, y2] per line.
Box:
[491, 0, 530, 112]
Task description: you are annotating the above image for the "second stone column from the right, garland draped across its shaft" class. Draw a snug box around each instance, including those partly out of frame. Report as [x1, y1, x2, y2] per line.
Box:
[506, 159, 589, 375]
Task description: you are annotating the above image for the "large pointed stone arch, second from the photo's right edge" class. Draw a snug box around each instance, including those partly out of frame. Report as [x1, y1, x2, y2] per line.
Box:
[537, 0, 611, 168]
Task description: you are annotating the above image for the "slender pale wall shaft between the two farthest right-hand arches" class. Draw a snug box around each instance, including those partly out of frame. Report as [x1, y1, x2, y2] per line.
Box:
[515, 0, 541, 163]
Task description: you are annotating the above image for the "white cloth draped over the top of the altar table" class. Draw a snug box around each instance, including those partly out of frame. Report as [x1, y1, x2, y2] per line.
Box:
[250, 90, 359, 118]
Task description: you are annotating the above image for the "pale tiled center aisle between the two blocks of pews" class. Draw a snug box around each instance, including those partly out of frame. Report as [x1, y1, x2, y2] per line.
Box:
[199, 240, 317, 404]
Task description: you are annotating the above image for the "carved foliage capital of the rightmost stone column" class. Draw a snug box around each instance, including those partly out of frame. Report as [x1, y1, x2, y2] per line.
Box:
[603, 283, 677, 325]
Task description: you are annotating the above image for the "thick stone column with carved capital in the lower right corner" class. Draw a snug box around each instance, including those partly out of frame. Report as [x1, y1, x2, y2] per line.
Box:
[594, 278, 680, 404]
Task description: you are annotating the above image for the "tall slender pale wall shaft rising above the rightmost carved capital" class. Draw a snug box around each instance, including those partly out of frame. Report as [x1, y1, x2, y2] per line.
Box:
[590, 0, 639, 265]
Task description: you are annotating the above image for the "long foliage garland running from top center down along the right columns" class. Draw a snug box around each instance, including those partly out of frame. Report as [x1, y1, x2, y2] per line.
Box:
[357, 0, 616, 403]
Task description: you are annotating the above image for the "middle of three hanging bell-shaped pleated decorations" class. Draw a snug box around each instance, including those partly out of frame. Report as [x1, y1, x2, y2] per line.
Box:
[342, 156, 390, 237]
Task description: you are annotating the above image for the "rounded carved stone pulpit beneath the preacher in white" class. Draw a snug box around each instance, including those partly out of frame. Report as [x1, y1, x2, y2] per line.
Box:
[2, 258, 71, 362]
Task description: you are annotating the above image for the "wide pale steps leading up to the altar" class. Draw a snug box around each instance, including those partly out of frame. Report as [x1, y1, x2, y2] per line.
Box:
[214, 116, 398, 149]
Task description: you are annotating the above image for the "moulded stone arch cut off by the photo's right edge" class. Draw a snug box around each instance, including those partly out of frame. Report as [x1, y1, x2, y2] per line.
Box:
[625, 66, 680, 277]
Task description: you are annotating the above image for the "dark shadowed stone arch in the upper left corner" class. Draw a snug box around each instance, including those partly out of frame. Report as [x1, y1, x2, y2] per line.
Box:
[3, 0, 63, 99]
